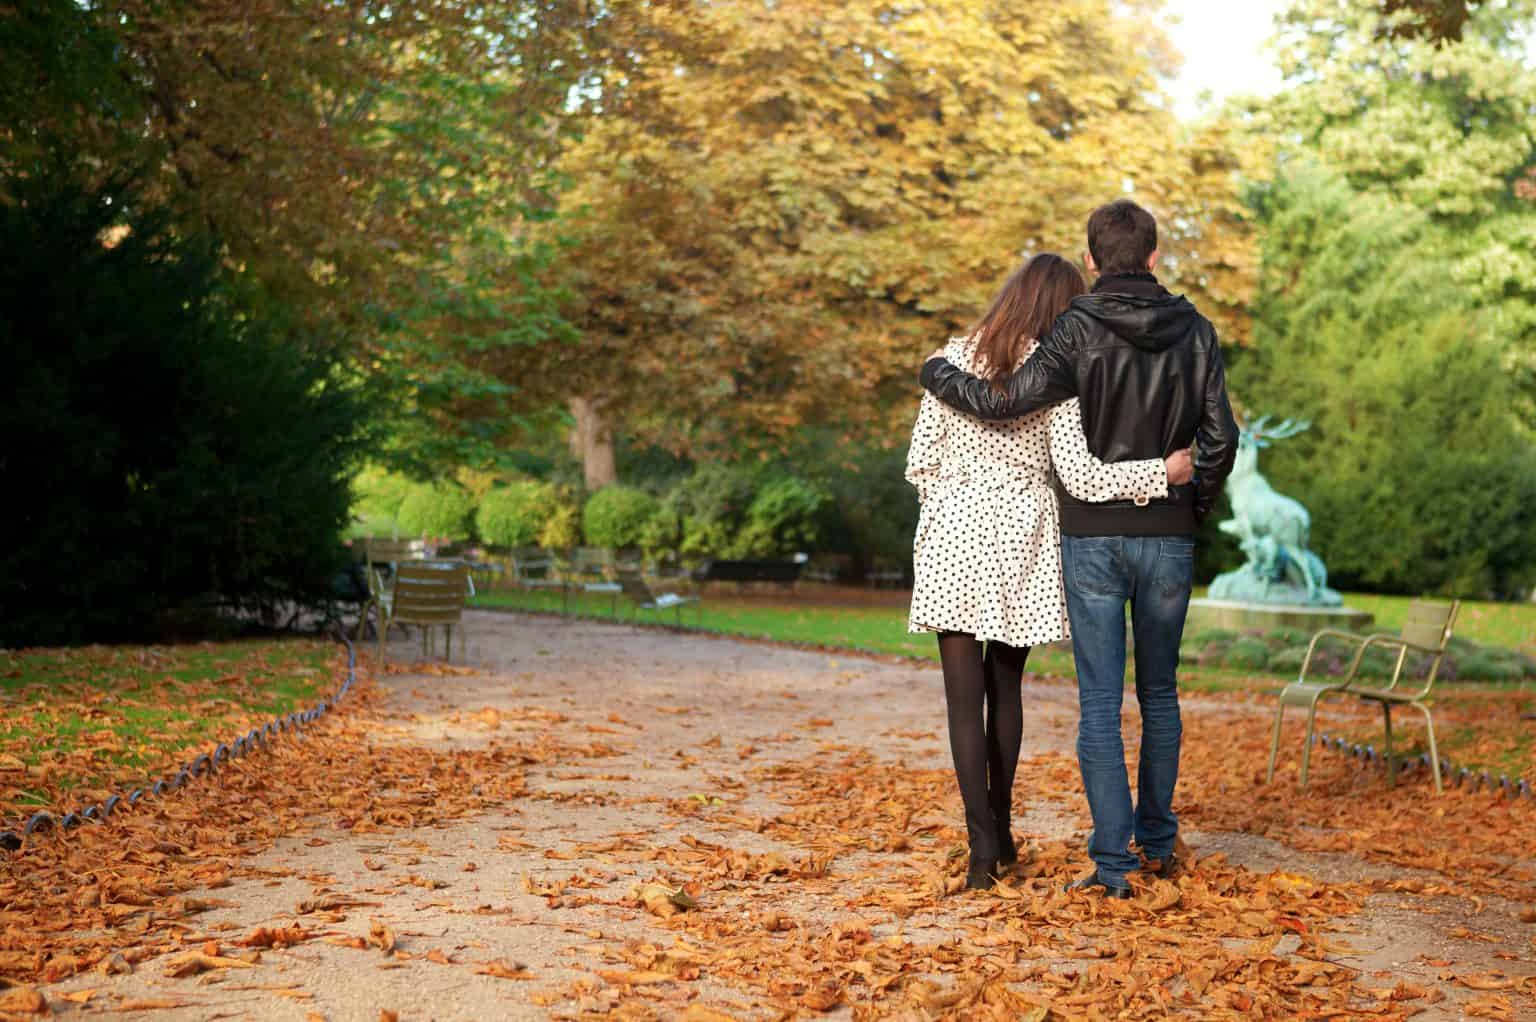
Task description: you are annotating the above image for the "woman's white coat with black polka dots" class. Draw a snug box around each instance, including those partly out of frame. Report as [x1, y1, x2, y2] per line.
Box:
[906, 338, 1167, 645]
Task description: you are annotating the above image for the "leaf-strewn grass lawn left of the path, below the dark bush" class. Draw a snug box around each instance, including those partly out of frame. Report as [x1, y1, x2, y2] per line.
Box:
[0, 641, 338, 815]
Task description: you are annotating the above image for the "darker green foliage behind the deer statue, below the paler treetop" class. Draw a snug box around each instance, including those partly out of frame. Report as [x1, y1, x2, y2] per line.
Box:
[1232, 164, 1536, 595]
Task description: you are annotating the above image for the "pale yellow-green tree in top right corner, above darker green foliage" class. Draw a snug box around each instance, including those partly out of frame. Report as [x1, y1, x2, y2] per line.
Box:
[1255, 0, 1536, 414]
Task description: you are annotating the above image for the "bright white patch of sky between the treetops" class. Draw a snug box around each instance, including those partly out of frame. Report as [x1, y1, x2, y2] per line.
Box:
[1166, 0, 1286, 117]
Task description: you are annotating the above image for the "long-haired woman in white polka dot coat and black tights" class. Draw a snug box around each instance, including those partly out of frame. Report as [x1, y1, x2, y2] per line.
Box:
[906, 254, 1192, 888]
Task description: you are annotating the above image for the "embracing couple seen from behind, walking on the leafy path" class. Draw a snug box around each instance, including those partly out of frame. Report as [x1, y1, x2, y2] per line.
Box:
[906, 200, 1238, 898]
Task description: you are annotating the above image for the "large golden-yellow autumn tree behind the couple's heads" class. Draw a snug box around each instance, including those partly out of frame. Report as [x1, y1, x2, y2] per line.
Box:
[499, 0, 1250, 478]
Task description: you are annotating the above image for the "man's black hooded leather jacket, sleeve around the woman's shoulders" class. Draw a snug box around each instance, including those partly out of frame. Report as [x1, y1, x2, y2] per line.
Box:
[922, 274, 1238, 536]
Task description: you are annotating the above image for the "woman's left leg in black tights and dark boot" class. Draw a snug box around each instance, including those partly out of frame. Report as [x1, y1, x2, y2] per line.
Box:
[938, 632, 998, 885]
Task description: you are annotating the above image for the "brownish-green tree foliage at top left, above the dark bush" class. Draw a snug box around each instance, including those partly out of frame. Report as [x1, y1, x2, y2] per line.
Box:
[0, 0, 590, 467]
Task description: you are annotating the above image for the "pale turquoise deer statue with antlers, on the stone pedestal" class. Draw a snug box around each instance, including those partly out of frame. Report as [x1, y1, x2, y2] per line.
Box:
[1221, 415, 1327, 598]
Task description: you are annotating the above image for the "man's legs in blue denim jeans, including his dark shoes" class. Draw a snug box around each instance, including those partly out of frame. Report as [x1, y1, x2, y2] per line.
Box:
[1061, 536, 1195, 887]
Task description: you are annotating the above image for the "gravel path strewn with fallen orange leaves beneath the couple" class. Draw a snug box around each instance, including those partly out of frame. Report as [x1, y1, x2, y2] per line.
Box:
[0, 615, 1536, 1022]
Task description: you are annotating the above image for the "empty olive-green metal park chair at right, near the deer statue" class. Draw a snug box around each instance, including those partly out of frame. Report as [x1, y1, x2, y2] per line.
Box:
[1267, 599, 1461, 795]
